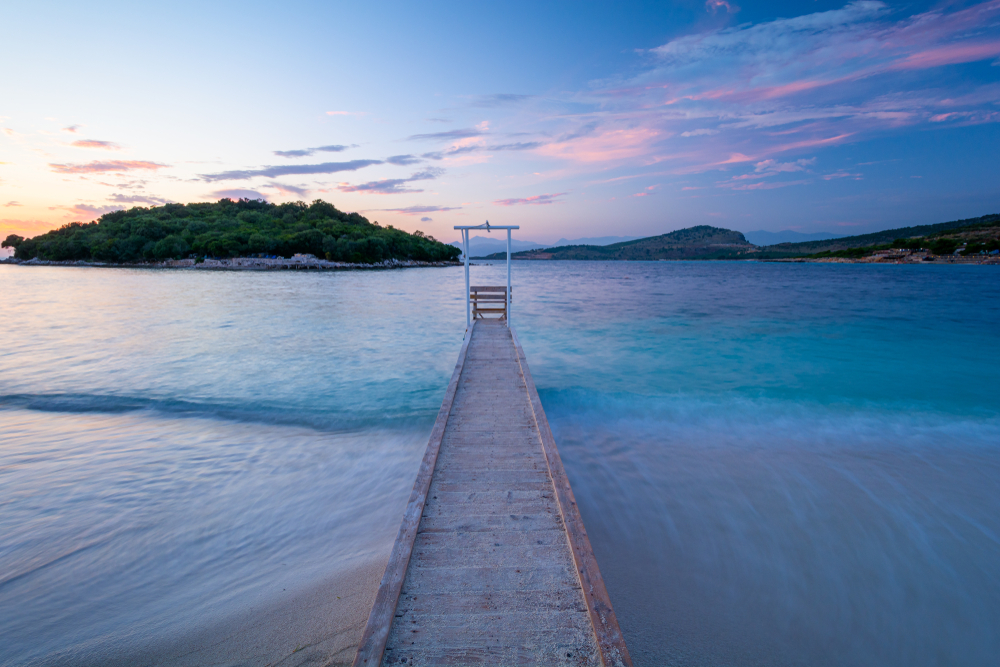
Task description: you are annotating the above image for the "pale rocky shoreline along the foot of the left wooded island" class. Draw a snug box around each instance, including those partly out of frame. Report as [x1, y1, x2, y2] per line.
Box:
[0, 256, 459, 271]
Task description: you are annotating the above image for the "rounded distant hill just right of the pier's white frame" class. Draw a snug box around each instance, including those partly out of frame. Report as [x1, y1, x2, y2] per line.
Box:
[477, 225, 753, 261]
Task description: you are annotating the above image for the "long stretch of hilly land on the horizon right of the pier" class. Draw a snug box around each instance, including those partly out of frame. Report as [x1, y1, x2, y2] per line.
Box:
[473, 214, 1000, 264]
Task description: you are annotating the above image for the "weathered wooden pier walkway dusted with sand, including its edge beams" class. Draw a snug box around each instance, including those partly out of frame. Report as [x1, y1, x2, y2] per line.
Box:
[354, 319, 632, 667]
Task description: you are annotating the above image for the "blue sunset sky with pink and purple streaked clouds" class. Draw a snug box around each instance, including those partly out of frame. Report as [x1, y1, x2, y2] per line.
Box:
[0, 0, 1000, 248]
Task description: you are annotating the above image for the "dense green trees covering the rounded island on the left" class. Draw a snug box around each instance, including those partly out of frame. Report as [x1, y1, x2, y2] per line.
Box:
[2, 199, 461, 264]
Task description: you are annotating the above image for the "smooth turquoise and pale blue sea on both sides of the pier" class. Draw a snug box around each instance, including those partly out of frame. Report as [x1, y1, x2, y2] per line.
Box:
[0, 262, 1000, 666]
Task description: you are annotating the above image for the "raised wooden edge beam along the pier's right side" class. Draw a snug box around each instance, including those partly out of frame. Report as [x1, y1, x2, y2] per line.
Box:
[510, 329, 632, 667]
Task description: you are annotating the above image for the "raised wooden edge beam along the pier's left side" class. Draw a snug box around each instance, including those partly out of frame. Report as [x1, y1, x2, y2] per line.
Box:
[354, 322, 476, 667]
